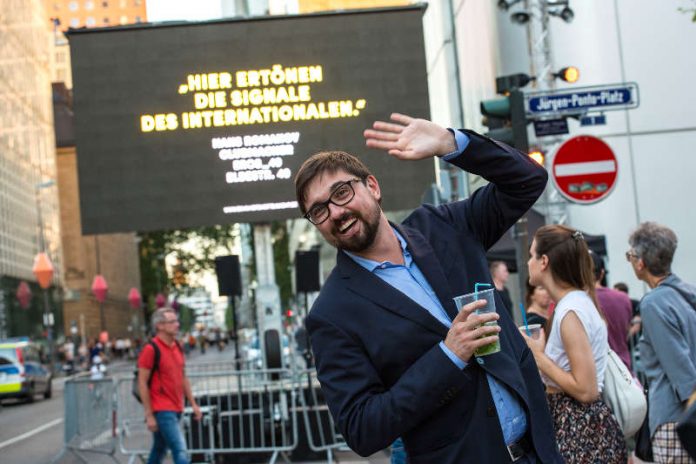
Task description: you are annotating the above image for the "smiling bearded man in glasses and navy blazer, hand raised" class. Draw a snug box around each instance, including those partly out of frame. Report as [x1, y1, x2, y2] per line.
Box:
[295, 114, 562, 464]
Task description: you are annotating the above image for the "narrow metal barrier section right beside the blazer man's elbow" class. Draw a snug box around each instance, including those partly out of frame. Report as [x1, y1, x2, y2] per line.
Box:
[297, 369, 348, 464]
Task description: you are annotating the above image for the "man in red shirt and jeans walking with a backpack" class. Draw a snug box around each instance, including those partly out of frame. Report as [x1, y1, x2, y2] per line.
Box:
[138, 307, 201, 464]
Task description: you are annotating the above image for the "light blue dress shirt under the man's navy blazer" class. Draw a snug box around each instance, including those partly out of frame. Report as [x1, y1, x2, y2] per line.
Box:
[346, 130, 527, 444]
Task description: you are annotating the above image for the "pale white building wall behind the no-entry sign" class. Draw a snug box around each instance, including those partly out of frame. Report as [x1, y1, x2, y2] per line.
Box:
[424, 0, 696, 297]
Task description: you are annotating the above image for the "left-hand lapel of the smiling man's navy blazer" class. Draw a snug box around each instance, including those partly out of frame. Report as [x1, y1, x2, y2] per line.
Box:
[336, 251, 448, 337]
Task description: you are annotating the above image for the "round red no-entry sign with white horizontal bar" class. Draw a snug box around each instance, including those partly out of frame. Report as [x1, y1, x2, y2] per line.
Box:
[551, 135, 619, 204]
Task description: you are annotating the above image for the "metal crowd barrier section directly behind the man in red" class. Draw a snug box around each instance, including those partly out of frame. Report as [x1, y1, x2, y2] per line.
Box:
[116, 363, 298, 464]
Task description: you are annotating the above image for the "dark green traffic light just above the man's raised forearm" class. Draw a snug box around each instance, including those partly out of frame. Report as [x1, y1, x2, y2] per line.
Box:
[481, 88, 529, 153]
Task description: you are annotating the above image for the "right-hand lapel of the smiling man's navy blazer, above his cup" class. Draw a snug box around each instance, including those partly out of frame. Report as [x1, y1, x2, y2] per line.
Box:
[392, 224, 459, 320]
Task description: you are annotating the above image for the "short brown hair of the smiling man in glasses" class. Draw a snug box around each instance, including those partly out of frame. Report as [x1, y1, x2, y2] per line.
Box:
[295, 151, 372, 214]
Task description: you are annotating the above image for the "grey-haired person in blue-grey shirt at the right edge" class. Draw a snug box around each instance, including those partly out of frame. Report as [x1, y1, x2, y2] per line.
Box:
[626, 222, 696, 464]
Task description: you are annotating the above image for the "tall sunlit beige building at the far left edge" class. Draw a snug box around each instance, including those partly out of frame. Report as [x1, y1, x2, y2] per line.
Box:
[0, 0, 61, 285]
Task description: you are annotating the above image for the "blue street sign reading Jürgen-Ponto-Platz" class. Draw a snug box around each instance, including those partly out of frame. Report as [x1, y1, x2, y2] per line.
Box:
[525, 82, 639, 117]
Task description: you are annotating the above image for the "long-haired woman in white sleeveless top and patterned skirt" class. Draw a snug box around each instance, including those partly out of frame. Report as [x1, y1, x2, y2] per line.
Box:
[523, 225, 627, 464]
